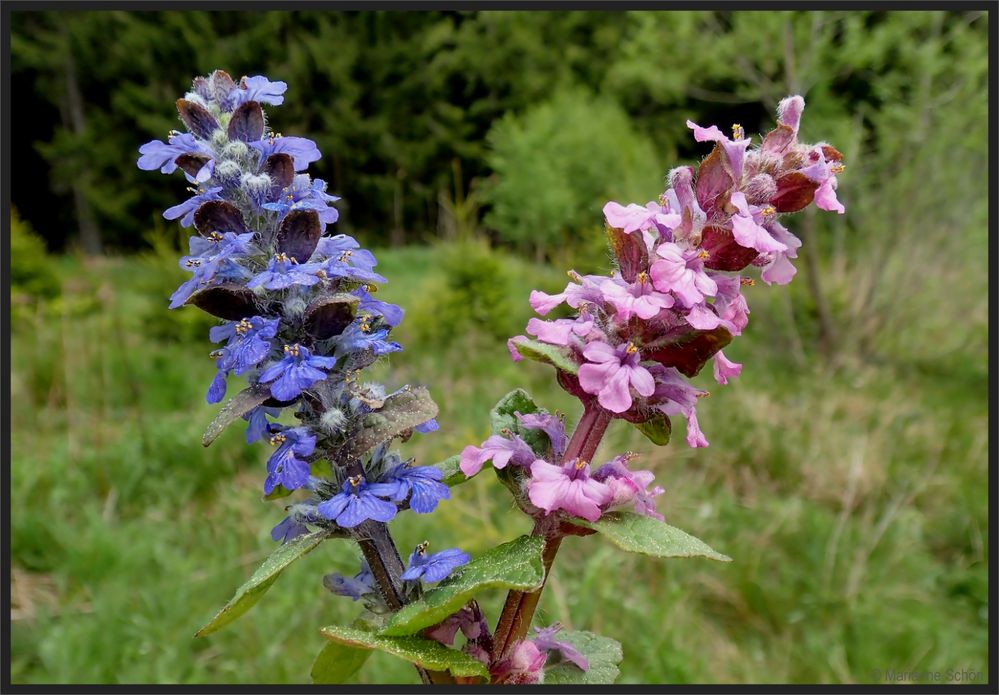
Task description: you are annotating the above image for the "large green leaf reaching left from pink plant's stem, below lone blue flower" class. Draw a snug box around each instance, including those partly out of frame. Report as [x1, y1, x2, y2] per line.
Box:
[381, 536, 545, 635]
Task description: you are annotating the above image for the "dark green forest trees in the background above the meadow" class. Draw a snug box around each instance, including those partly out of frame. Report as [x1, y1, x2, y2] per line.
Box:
[12, 11, 986, 253]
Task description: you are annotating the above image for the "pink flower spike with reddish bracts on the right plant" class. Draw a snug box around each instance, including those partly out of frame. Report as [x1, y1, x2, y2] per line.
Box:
[474, 96, 844, 521]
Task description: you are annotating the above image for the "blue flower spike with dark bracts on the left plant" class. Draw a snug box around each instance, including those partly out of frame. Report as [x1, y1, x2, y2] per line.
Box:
[138, 70, 458, 583]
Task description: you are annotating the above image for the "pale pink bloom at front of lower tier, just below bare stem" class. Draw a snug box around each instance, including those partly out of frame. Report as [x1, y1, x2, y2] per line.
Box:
[527, 459, 614, 521]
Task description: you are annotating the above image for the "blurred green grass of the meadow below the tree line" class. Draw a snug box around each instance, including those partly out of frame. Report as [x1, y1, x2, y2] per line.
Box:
[10, 248, 988, 683]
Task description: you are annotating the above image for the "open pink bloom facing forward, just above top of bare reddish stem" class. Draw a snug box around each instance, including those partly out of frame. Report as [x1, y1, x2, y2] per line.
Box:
[579, 342, 656, 413]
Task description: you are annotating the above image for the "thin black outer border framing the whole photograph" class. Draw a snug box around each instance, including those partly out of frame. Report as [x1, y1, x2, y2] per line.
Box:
[0, 0, 999, 694]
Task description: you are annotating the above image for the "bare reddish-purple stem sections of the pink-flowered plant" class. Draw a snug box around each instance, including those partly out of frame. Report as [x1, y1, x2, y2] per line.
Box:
[491, 402, 610, 661]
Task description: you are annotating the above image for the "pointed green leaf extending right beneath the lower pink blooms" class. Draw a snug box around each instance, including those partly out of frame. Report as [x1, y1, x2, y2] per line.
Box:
[573, 512, 732, 562]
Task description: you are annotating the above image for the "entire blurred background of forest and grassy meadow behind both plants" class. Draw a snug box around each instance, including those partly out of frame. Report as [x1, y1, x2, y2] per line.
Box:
[9, 12, 989, 683]
